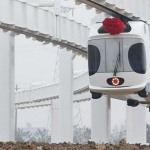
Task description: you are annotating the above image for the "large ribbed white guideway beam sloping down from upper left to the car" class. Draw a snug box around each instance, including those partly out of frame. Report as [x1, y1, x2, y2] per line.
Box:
[0, 0, 89, 57]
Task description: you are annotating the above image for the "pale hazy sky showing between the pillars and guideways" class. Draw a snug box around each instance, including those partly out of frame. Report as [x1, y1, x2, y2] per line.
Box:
[15, 1, 150, 130]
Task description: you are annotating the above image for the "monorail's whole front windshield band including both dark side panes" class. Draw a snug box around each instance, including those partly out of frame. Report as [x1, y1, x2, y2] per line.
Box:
[88, 38, 146, 75]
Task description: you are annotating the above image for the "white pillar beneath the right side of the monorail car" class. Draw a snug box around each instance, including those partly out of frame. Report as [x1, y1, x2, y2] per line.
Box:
[126, 106, 146, 144]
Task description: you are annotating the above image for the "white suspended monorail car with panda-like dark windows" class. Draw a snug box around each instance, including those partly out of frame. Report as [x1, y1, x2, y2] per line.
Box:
[88, 21, 150, 107]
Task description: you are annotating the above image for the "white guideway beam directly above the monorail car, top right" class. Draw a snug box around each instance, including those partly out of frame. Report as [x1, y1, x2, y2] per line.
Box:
[75, 0, 150, 24]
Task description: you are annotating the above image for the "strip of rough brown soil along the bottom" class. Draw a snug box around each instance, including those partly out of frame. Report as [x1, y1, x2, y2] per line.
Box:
[0, 139, 150, 150]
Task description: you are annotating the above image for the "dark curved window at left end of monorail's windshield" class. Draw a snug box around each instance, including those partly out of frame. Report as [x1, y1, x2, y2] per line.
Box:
[88, 45, 100, 76]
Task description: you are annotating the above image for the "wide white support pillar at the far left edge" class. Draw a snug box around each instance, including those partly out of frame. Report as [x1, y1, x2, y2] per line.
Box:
[0, 29, 15, 141]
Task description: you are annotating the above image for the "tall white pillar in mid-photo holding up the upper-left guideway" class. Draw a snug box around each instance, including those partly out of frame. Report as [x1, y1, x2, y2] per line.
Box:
[59, 51, 75, 142]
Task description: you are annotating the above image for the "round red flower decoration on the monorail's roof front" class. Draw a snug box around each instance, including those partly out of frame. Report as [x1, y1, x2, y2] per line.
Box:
[103, 18, 124, 35]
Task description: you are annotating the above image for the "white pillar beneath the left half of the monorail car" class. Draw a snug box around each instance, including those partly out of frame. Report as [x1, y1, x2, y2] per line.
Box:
[91, 96, 111, 144]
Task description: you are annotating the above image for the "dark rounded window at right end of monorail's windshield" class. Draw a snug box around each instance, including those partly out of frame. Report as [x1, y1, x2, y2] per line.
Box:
[128, 43, 146, 74]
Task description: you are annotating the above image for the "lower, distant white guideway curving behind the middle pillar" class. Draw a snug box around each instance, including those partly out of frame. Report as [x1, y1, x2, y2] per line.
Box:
[15, 72, 91, 109]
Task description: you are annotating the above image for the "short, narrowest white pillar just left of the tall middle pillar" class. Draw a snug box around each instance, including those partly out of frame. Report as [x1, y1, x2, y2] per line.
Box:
[51, 99, 59, 143]
